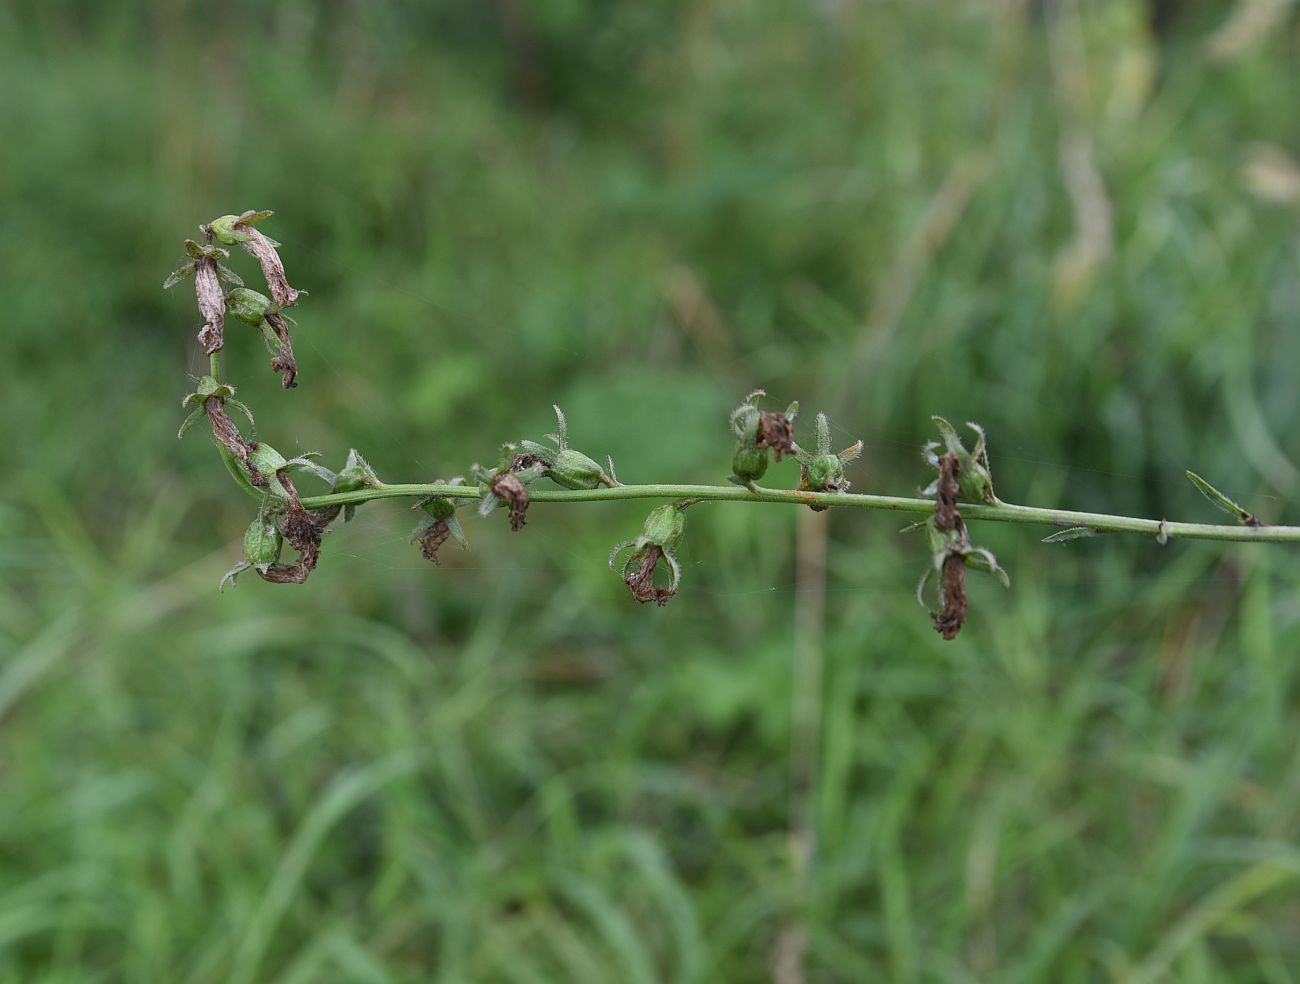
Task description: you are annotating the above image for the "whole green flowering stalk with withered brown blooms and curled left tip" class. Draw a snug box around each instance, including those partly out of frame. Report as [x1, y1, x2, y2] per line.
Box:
[172, 211, 1300, 640]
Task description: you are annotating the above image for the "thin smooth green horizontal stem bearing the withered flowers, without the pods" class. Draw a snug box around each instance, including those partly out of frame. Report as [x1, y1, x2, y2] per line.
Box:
[303, 484, 1300, 543]
